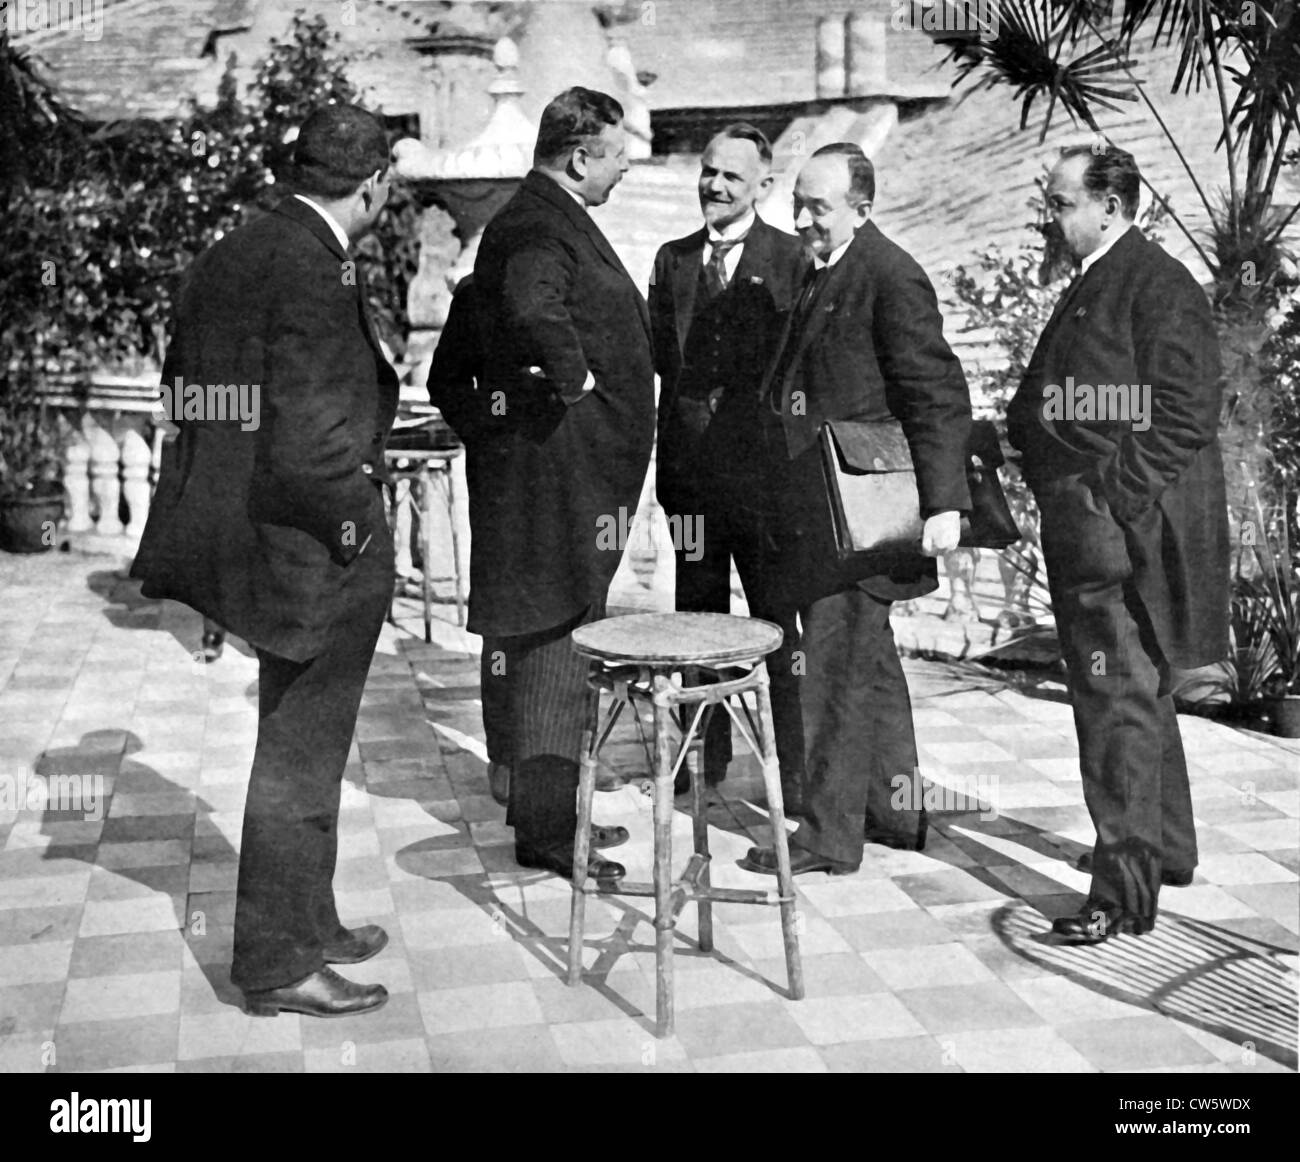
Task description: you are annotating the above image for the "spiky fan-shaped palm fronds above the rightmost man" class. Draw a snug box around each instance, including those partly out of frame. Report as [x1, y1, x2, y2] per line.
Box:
[936, 0, 1300, 307]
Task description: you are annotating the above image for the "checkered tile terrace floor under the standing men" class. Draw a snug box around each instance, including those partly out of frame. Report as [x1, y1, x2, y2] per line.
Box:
[0, 555, 1300, 1072]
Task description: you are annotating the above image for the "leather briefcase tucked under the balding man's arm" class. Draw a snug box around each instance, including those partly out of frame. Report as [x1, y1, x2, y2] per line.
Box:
[822, 420, 1021, 562]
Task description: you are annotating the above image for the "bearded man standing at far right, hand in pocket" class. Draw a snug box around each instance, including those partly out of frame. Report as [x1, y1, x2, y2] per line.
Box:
[1008, 146, 1229, 944]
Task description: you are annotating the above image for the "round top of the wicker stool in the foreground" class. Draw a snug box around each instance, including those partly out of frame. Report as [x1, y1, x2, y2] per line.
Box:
[573, 613, 781, 665]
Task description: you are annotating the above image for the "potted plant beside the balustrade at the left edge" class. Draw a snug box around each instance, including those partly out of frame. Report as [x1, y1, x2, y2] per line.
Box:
[0, 403, 64, 552]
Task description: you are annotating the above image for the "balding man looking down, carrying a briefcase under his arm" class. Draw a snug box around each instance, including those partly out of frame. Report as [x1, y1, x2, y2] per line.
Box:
[741, 144, 971, 873]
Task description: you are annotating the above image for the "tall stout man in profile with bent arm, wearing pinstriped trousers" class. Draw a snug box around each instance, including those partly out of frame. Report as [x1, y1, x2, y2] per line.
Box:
[447, 87, 654, 879]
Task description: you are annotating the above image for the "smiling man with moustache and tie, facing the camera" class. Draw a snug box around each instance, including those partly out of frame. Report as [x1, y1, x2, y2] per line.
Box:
[650, 123, 807, 812]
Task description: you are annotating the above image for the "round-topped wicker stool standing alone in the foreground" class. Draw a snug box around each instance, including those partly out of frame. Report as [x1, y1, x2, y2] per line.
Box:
[568, 613, 803, 1037]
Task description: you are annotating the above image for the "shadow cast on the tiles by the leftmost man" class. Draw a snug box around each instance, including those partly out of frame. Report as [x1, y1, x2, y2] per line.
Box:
[33, 728, 241, 1005]
